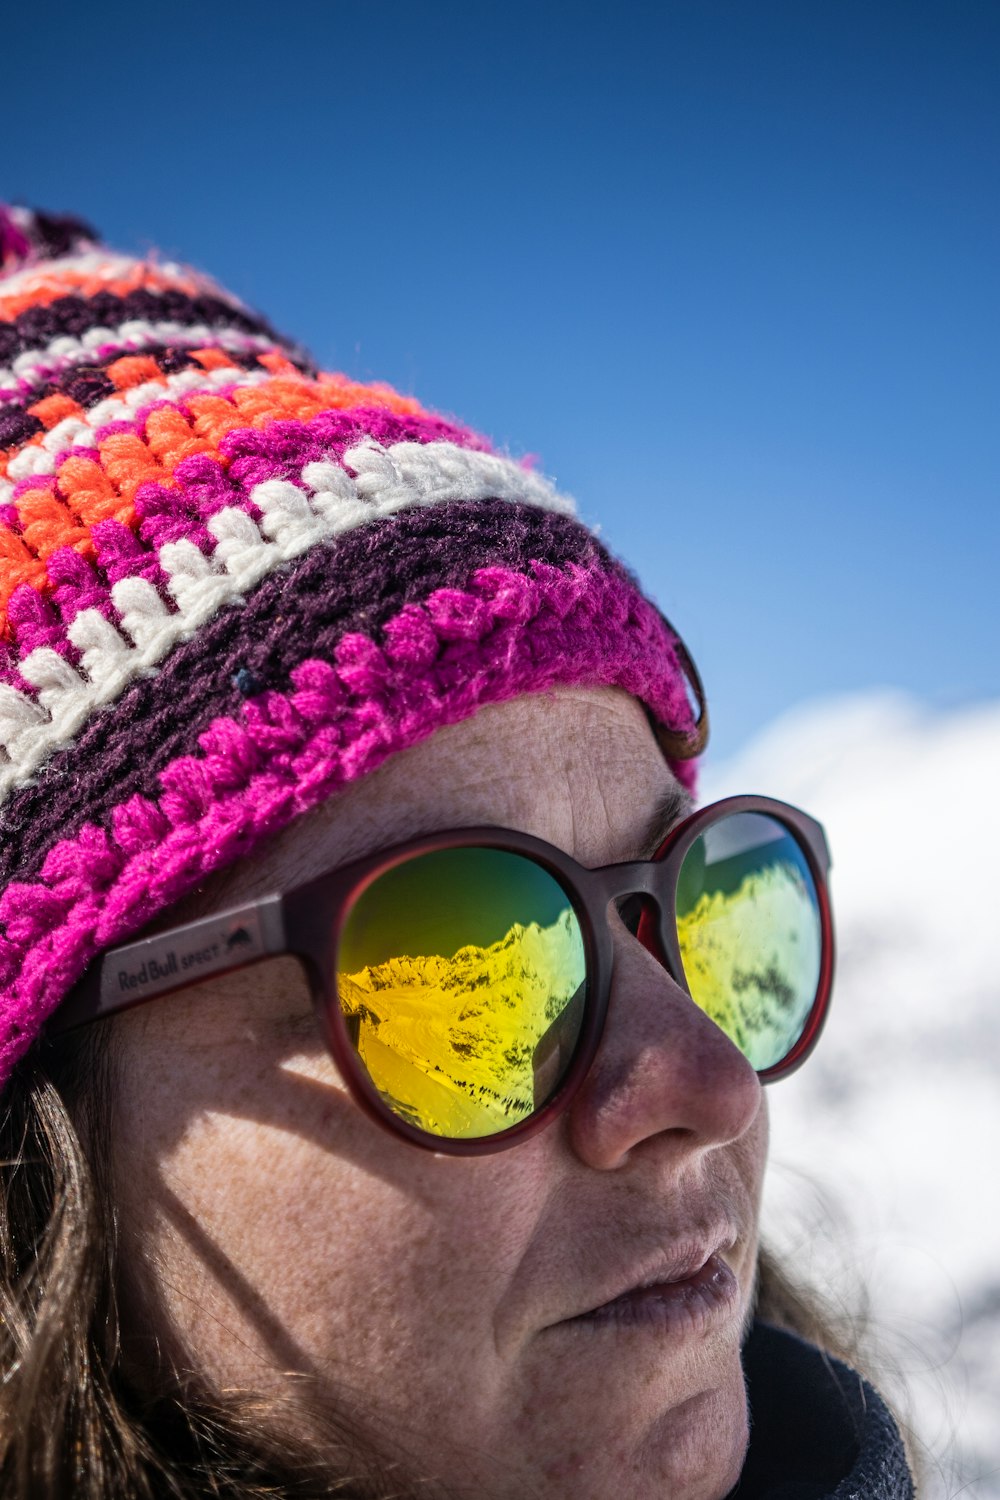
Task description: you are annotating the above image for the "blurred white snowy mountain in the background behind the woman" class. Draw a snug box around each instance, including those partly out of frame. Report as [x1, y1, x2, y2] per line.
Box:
[702, 695, 1000, 1500]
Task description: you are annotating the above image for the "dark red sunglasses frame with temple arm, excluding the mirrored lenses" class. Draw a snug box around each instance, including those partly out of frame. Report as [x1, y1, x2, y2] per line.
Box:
[56, 797, 834, 1157]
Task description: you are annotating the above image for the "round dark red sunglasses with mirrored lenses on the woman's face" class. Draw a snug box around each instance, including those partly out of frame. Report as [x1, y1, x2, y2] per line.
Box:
[55, 797, 834, 1155]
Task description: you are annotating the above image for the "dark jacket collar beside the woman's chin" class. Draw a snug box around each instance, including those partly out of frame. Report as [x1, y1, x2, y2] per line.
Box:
[732, 1323, 913, 1500]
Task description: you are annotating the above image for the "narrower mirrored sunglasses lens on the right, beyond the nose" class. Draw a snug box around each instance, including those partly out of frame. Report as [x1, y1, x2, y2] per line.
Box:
[678, 813, 822, 1071]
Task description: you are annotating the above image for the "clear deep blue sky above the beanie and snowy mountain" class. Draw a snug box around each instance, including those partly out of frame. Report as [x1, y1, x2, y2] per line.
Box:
[0, 0, 1000, 755]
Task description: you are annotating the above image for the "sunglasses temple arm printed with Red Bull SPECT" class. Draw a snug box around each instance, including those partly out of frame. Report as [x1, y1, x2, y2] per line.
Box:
[48, 896, 288, 1034]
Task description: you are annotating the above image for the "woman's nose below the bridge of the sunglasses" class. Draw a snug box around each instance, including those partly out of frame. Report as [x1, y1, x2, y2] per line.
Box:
[568, 923, 762, 1172]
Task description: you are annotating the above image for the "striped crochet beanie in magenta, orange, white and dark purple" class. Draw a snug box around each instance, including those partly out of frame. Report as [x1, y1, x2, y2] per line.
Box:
[0, 207, 705, 1083]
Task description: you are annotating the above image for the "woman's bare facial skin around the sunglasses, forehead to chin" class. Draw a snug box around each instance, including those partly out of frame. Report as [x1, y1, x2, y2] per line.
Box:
[115, 690, 766, 1500]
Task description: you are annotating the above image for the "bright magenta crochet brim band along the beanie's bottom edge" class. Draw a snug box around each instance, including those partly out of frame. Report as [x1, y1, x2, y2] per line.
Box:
[0, 552, 690, 1079]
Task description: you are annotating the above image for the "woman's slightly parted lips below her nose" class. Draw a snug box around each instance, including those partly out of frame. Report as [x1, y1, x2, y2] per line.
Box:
[564, 1251, 741, 1337]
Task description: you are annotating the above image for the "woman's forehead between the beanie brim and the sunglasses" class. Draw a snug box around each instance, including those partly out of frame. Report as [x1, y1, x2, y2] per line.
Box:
[206, 689, 687, 909]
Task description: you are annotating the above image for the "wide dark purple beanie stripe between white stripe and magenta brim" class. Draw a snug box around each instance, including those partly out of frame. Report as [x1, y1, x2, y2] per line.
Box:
[0, 501, 602, 887]
